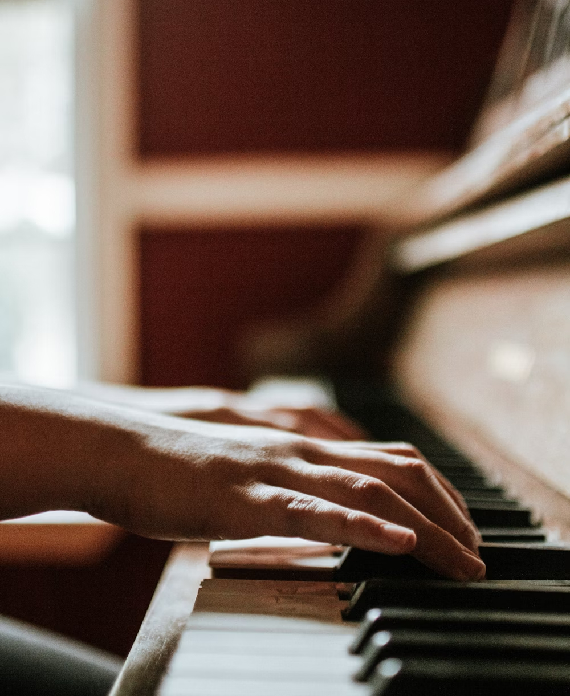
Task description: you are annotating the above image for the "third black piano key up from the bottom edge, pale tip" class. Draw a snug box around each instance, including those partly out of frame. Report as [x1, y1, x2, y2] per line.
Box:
[349, 607, 570, 655]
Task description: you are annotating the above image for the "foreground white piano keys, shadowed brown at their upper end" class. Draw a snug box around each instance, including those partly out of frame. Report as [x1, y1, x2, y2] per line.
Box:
[156, 580, 360, 696]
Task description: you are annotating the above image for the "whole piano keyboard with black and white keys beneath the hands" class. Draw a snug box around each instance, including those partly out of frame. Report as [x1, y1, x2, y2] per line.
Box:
[155, 388, 570, 696]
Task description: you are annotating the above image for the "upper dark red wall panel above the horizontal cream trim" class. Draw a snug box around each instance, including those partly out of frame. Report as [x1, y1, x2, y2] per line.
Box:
[138, 0, 512, 157]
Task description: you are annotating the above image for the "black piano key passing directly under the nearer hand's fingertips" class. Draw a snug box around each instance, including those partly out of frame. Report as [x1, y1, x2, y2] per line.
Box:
[335, 543, 570, 582]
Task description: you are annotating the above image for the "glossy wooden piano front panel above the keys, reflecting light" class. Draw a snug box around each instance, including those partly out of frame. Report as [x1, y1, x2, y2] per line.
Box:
[395, 258, 570, 538]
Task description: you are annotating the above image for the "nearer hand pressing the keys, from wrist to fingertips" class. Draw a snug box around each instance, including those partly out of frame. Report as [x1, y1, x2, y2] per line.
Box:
[91, 417, 484, 580]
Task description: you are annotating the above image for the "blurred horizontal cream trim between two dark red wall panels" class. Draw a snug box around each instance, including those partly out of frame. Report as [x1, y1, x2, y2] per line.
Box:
[129, 152, 450, 226]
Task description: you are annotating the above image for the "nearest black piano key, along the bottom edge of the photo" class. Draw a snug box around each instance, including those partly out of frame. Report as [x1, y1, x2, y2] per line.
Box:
[370, 658, 570, 696]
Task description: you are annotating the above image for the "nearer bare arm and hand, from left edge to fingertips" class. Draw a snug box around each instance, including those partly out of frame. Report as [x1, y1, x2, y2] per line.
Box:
[0, 386, 485, 580]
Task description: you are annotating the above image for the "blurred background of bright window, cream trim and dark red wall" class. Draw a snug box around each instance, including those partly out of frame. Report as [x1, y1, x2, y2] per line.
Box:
[0, 0, 511, 654]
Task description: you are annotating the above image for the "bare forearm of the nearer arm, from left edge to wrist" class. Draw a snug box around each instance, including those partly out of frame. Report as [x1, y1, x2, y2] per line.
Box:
[0, 386, 151, 519]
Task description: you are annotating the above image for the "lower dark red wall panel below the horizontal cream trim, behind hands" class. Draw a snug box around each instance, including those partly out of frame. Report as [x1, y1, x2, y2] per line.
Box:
[140, 226, 364, 388]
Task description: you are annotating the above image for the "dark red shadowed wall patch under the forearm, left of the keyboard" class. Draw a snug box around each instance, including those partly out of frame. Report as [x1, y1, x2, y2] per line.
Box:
[0, 534, 172, 656]
